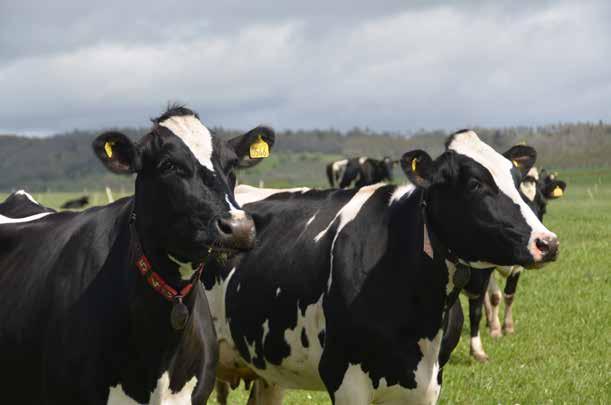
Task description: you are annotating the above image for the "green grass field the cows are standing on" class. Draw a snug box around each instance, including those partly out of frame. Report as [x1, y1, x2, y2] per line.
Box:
[0, 169, 611, 404]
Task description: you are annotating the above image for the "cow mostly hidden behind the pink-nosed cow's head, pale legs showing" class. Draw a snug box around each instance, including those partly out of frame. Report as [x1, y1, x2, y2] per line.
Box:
[455, 165, 566, 362]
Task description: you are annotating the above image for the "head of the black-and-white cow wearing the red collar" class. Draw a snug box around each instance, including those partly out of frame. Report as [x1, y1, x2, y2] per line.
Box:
[93, 107, 274, 262]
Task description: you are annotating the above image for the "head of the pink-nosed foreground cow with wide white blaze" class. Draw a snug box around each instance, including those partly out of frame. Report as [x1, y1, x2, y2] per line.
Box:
[401, 131, 559, 267]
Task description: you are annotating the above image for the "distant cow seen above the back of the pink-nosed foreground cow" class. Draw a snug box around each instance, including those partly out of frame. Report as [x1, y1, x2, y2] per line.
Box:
[327, 156, 394, 188]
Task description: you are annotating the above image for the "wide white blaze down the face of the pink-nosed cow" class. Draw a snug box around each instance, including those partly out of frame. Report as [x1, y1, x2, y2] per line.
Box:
[448, 131, 556, 261]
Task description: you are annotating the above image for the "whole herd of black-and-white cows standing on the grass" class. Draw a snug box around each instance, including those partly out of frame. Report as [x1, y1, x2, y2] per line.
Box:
[0, 107, 566, 405]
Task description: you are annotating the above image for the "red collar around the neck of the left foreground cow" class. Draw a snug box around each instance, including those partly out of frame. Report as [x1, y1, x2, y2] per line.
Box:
[129, 212, 204, 304]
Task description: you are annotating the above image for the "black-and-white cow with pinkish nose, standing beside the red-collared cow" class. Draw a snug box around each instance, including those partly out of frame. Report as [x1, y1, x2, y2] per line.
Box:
[202, 131, 558, 405]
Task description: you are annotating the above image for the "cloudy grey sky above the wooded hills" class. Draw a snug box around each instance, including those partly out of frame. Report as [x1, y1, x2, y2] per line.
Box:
[0, 0, 611, 135]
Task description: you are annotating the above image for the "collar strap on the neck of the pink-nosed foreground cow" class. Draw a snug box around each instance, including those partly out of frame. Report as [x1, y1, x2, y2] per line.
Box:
[420, 189, 471, 310]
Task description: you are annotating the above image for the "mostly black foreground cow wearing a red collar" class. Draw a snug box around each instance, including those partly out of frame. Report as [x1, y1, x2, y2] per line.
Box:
[0, 107, 274, 404]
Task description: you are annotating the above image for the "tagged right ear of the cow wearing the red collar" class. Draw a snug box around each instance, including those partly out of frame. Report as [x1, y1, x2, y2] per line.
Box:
[227, 126, 276, 169]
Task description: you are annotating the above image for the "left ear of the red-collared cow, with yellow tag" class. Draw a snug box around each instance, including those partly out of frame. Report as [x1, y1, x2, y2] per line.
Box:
[93, 131, 142, 174]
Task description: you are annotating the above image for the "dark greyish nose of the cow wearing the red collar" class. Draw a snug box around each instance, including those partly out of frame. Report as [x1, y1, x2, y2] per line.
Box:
[214, 211, 256, 250]
